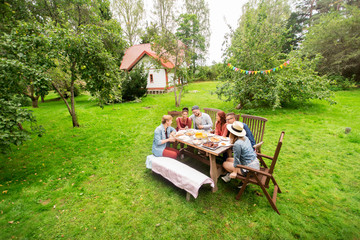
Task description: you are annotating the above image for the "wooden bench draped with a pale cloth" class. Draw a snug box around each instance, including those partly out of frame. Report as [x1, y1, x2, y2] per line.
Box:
[146, 155, 215, 201]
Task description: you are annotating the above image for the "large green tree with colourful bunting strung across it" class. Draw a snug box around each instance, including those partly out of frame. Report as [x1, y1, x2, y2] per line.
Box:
[217, 0, 329, 108]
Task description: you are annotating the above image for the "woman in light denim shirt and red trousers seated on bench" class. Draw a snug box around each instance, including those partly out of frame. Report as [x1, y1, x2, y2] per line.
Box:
[152, 115, 180, 159]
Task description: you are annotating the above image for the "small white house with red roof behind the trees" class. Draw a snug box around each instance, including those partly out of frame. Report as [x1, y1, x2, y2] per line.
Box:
[120, 42, 183, 94]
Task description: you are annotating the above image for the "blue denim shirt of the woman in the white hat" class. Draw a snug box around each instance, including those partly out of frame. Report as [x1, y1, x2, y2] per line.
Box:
[233, 136, 256, 167]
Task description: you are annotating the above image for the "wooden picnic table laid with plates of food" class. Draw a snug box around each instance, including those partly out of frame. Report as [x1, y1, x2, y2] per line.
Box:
[175, 129, 232, 192]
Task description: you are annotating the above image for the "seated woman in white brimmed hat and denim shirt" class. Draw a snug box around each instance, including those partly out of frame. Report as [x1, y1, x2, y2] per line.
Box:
[222, 121, 260, 187]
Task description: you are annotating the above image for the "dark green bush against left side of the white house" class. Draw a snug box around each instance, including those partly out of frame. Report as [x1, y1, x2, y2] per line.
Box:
[121, 66, 148, 101]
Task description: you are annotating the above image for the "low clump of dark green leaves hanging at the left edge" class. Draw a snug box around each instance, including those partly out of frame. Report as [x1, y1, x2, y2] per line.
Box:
[0, 98, 44, 151]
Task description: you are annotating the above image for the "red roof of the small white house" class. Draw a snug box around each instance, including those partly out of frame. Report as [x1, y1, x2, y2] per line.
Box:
[120, 43, 184, 71]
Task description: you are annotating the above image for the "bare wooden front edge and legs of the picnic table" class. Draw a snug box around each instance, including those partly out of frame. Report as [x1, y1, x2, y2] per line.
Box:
[175, 136, 232, 192]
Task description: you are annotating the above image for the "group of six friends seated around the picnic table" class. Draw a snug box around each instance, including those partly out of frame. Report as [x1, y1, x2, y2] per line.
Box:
[152, 105, 260, 187]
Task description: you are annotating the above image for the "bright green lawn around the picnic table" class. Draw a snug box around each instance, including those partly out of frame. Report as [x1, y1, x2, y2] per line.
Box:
[0, 82, 360, 239]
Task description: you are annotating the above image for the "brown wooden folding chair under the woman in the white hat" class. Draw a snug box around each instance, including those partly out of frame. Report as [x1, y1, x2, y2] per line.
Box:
[236, 132, 285, 214]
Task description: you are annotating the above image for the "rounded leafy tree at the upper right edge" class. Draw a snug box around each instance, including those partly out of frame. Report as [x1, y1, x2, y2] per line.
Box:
[303, 6, 360, 82]
